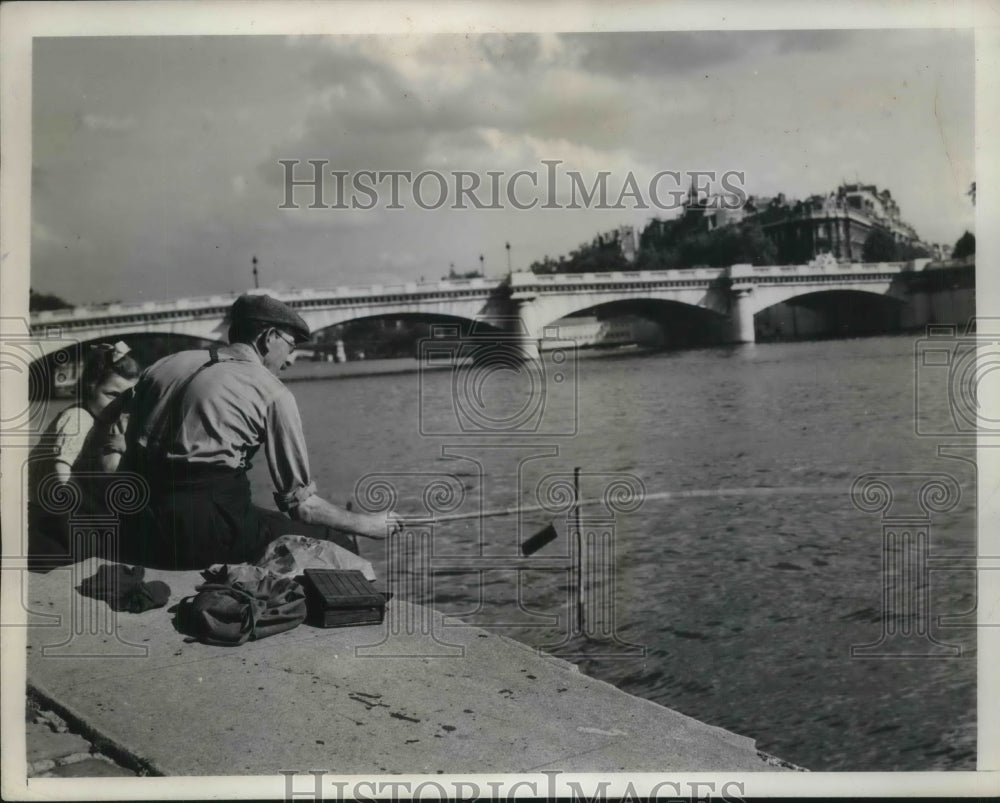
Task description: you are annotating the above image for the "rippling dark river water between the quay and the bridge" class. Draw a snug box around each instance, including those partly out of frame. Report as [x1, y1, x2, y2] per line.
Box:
[254, 336, 976, 770]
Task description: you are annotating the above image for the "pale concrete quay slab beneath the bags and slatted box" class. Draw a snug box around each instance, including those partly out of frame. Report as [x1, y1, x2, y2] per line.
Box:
[26, 559, 799, 776]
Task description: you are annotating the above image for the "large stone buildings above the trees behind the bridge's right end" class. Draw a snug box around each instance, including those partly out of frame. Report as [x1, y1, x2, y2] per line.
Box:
[682, 184, 933, 264]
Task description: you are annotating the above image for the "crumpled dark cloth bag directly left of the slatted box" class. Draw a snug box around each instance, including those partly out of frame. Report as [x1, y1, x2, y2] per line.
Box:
[176, 567, 306, 646]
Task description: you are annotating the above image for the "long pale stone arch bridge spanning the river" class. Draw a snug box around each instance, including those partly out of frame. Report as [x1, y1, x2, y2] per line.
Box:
[25, 259, 960, 364]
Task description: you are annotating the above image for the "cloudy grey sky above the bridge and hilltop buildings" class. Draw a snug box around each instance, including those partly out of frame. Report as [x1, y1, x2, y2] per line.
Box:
[31, 30, 974, 303]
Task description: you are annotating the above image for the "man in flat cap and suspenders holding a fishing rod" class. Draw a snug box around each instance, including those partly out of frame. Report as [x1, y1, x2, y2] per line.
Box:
[114, 295, 399, 569]
